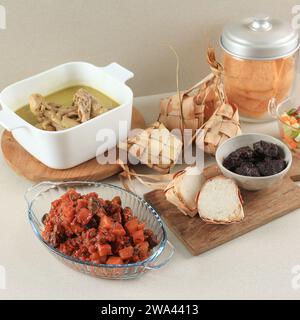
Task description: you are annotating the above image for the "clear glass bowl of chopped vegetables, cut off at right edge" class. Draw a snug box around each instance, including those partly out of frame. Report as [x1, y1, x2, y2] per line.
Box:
[269, 98, 300, 156]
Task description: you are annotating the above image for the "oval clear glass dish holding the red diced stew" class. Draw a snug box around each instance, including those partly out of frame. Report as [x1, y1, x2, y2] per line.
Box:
[25, 181, 175, 279]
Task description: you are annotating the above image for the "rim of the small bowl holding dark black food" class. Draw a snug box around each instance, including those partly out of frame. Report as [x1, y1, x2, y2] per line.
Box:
[216, 133, 292, 181]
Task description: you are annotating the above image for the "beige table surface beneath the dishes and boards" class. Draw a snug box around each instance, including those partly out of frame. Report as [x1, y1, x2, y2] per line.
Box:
[0, 96, 300, 299]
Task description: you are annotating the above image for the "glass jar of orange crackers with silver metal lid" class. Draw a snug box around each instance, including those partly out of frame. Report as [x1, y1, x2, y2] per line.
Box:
[220, 15, 299, 122]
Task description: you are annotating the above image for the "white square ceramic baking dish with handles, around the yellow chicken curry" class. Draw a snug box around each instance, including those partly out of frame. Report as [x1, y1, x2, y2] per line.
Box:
[0, 62, 133, 169]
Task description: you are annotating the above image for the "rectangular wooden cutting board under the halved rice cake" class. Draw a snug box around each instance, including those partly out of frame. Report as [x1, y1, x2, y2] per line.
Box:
[144, 158, 300, 255]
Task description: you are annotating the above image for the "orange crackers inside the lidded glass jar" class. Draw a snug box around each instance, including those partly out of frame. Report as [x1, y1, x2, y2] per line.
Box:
[224, 53, 295, 118]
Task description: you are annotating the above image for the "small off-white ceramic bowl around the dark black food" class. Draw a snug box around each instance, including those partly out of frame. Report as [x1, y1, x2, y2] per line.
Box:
[216, 133, 293, 191]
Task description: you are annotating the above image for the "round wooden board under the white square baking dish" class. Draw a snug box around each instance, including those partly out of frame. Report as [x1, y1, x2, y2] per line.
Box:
[1, 108, 145, 182]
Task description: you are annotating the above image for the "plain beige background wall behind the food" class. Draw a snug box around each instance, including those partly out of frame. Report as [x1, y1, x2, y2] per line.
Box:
[0, 0, 300, 96]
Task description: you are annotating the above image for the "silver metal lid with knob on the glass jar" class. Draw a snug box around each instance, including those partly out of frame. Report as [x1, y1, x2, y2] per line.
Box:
[220, 15, 300, 60]
